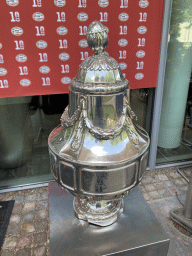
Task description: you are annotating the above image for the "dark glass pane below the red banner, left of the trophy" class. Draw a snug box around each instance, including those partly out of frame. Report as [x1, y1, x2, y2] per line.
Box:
[0, 94, 68, 189]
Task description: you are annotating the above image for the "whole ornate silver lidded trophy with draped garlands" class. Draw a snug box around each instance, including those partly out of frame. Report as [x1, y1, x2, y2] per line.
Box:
[48, 21, 149, 226]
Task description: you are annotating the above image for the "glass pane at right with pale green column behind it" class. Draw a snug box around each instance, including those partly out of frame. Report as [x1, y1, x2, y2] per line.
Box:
[157, 0, 192, 164]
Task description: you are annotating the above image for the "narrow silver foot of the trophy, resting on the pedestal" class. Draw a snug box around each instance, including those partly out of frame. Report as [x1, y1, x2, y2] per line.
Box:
[73, 197, 123, 227]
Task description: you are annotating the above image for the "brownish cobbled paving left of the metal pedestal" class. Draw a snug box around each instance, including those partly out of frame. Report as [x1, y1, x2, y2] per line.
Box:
[0, 187, 49, 256]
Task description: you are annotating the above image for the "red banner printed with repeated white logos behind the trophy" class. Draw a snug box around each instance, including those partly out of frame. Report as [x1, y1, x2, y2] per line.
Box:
[0, 0, 164, 97]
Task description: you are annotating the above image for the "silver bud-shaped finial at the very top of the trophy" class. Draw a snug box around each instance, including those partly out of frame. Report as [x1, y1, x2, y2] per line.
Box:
[87, 21, 109, 54]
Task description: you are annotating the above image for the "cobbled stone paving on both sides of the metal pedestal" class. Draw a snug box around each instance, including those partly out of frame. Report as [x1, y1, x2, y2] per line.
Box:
[0, 168, 192, 256]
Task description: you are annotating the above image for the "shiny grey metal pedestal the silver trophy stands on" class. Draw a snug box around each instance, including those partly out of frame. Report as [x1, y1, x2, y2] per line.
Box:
[49, 182, 169, 256]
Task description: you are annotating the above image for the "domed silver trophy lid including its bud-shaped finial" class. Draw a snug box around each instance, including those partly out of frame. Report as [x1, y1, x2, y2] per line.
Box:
[71, 21, 128, 94]
